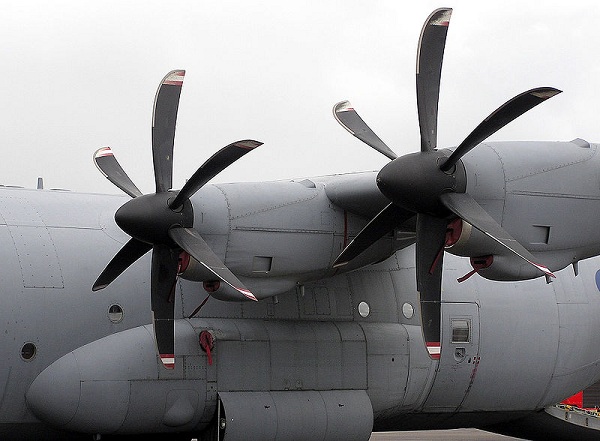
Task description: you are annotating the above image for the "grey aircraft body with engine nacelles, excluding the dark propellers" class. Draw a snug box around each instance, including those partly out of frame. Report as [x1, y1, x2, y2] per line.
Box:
[0, 143, 600, 439]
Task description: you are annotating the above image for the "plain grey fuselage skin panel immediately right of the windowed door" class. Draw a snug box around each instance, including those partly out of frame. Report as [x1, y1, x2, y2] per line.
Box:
[452, 272, 570, 411]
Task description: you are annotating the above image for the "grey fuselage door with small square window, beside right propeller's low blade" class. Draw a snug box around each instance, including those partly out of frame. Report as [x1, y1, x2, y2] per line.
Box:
[425, 302, 479, 411]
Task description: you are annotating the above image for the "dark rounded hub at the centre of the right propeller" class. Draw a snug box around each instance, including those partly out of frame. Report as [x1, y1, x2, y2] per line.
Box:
[377, 150, 466, 216]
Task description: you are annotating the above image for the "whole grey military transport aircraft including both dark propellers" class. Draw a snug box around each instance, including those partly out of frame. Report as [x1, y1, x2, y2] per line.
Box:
[0, 9, 600, 440]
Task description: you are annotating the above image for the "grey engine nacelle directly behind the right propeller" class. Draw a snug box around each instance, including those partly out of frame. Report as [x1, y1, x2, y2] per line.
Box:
[464, 141, 600, 280]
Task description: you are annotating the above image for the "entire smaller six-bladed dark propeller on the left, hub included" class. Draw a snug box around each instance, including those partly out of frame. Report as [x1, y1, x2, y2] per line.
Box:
[92, 70, 262, 369]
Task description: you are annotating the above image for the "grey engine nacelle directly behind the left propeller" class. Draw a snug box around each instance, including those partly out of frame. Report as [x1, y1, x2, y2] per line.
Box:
[209, 181, 393, 298]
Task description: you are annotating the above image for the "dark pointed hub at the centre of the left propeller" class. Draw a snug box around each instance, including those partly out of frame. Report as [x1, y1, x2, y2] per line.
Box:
[115, 192, 194, 245]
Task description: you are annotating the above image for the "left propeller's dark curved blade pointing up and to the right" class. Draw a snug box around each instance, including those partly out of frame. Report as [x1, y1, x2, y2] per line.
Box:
[169, 139, 263, 209]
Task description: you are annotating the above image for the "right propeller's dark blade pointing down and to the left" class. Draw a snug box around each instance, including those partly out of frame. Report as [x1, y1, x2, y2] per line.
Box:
[333, 204, 415, 268]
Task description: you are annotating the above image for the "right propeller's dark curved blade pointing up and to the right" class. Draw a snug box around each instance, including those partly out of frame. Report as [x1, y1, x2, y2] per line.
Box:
[440, 87, 562, 171]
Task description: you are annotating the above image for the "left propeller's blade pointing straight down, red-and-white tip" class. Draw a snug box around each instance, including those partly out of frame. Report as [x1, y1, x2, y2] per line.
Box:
[151, 244, 179, 369]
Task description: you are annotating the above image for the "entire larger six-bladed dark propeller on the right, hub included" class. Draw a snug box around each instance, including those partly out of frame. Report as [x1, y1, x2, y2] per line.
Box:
[334, 9, 560, 358]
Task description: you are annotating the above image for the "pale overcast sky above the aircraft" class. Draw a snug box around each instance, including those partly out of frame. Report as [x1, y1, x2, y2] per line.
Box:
[0, 0, 600, 193]
